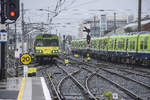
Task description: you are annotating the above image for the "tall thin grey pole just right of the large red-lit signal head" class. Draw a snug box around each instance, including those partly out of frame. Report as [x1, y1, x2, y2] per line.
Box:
[21, 3, 25, 52]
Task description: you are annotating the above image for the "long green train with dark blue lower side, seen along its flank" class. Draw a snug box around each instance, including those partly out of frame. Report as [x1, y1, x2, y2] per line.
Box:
[71, 32, 150, 65]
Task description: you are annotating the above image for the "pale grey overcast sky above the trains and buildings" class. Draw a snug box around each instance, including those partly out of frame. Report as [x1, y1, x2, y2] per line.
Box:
[21, 0, 150, 35]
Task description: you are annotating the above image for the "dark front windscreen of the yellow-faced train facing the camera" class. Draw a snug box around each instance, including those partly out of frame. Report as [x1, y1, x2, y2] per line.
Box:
[35, 39, 59, 47]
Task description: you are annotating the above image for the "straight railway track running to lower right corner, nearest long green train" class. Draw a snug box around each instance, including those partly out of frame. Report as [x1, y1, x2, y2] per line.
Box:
[64, 55, 150, 100]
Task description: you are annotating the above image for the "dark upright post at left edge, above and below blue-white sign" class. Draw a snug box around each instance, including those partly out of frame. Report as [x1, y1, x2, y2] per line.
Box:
[0, 0, 6, 80]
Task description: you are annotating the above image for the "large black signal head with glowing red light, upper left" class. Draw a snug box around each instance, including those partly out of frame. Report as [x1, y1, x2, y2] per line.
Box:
[6, 0, 20, 20]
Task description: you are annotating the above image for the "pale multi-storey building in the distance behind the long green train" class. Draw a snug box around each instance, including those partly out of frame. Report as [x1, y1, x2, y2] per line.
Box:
[79, 14, 134, 38]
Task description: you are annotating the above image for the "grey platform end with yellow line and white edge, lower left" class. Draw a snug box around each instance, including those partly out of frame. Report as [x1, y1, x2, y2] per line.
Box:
[0, 77, 52, 100]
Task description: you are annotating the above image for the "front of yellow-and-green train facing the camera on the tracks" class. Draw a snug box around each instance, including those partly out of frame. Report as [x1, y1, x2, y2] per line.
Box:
[34, 34, 60, 63]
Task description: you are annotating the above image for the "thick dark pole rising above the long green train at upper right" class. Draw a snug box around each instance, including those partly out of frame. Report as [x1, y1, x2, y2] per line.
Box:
[138, 0, 142, 32]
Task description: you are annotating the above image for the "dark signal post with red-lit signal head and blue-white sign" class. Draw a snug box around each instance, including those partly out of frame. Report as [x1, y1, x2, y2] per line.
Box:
[0, 0, 19, 81]
